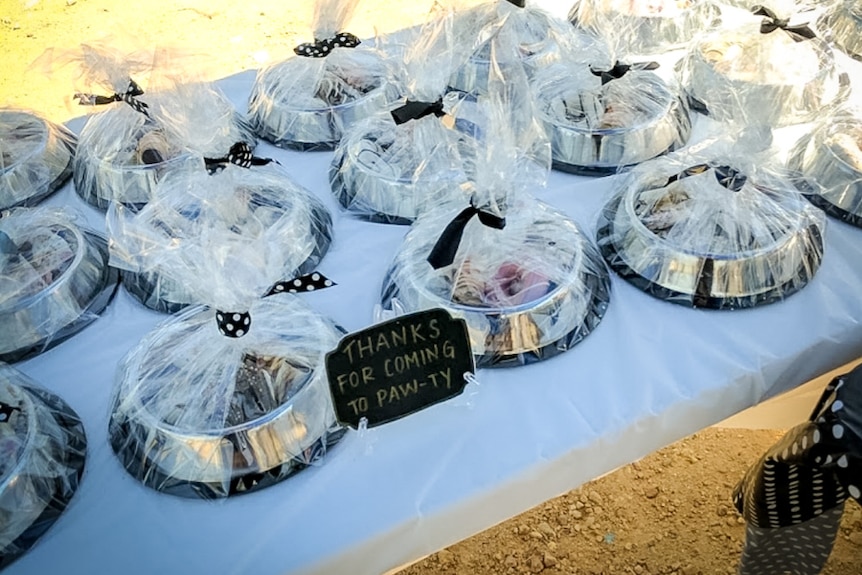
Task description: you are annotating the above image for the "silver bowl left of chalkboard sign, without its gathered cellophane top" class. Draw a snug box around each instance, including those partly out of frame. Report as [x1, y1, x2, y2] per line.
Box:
[109, 294, 344, 499]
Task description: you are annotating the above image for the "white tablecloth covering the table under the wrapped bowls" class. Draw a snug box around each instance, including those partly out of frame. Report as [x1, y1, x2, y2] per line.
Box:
[4, 68, 862, 575]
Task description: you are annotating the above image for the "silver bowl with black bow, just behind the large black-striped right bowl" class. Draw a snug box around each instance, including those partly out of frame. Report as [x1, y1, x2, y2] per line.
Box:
[537, 69, 691, 175]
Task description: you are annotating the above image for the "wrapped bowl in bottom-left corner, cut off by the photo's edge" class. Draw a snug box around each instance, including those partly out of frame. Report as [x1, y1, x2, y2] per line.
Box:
[0, 363, 87, 569]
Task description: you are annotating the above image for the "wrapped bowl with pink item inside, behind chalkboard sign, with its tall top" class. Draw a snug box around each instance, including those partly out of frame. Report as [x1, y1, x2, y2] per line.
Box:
[381, 59, 610, 367]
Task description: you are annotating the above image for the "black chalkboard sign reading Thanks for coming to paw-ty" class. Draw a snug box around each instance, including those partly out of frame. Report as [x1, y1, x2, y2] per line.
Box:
[326, 309, 475, 429]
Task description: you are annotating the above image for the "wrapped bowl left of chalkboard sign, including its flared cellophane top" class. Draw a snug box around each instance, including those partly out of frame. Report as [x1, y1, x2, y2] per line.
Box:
[109, 165, 343, 498]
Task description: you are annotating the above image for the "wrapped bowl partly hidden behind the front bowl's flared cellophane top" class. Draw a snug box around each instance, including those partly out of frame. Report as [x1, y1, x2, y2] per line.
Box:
[108, 164, 332, 313]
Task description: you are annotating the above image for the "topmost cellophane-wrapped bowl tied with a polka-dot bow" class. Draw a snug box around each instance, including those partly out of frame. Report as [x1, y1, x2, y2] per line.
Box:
[248, 0, 398, 150]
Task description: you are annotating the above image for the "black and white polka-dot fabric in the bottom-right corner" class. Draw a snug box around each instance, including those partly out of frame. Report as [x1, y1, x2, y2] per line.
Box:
[734, 366, 862, 575]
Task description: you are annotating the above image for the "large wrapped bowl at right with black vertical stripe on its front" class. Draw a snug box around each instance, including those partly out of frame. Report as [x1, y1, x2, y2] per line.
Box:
[598, 143, 826, 309]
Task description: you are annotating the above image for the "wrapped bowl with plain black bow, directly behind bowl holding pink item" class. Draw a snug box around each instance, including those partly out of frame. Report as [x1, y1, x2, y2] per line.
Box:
[330, 3, 481, 224]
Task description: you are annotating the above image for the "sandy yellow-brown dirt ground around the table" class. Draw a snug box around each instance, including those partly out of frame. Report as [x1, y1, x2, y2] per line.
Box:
[0, 0, 862, 575]
